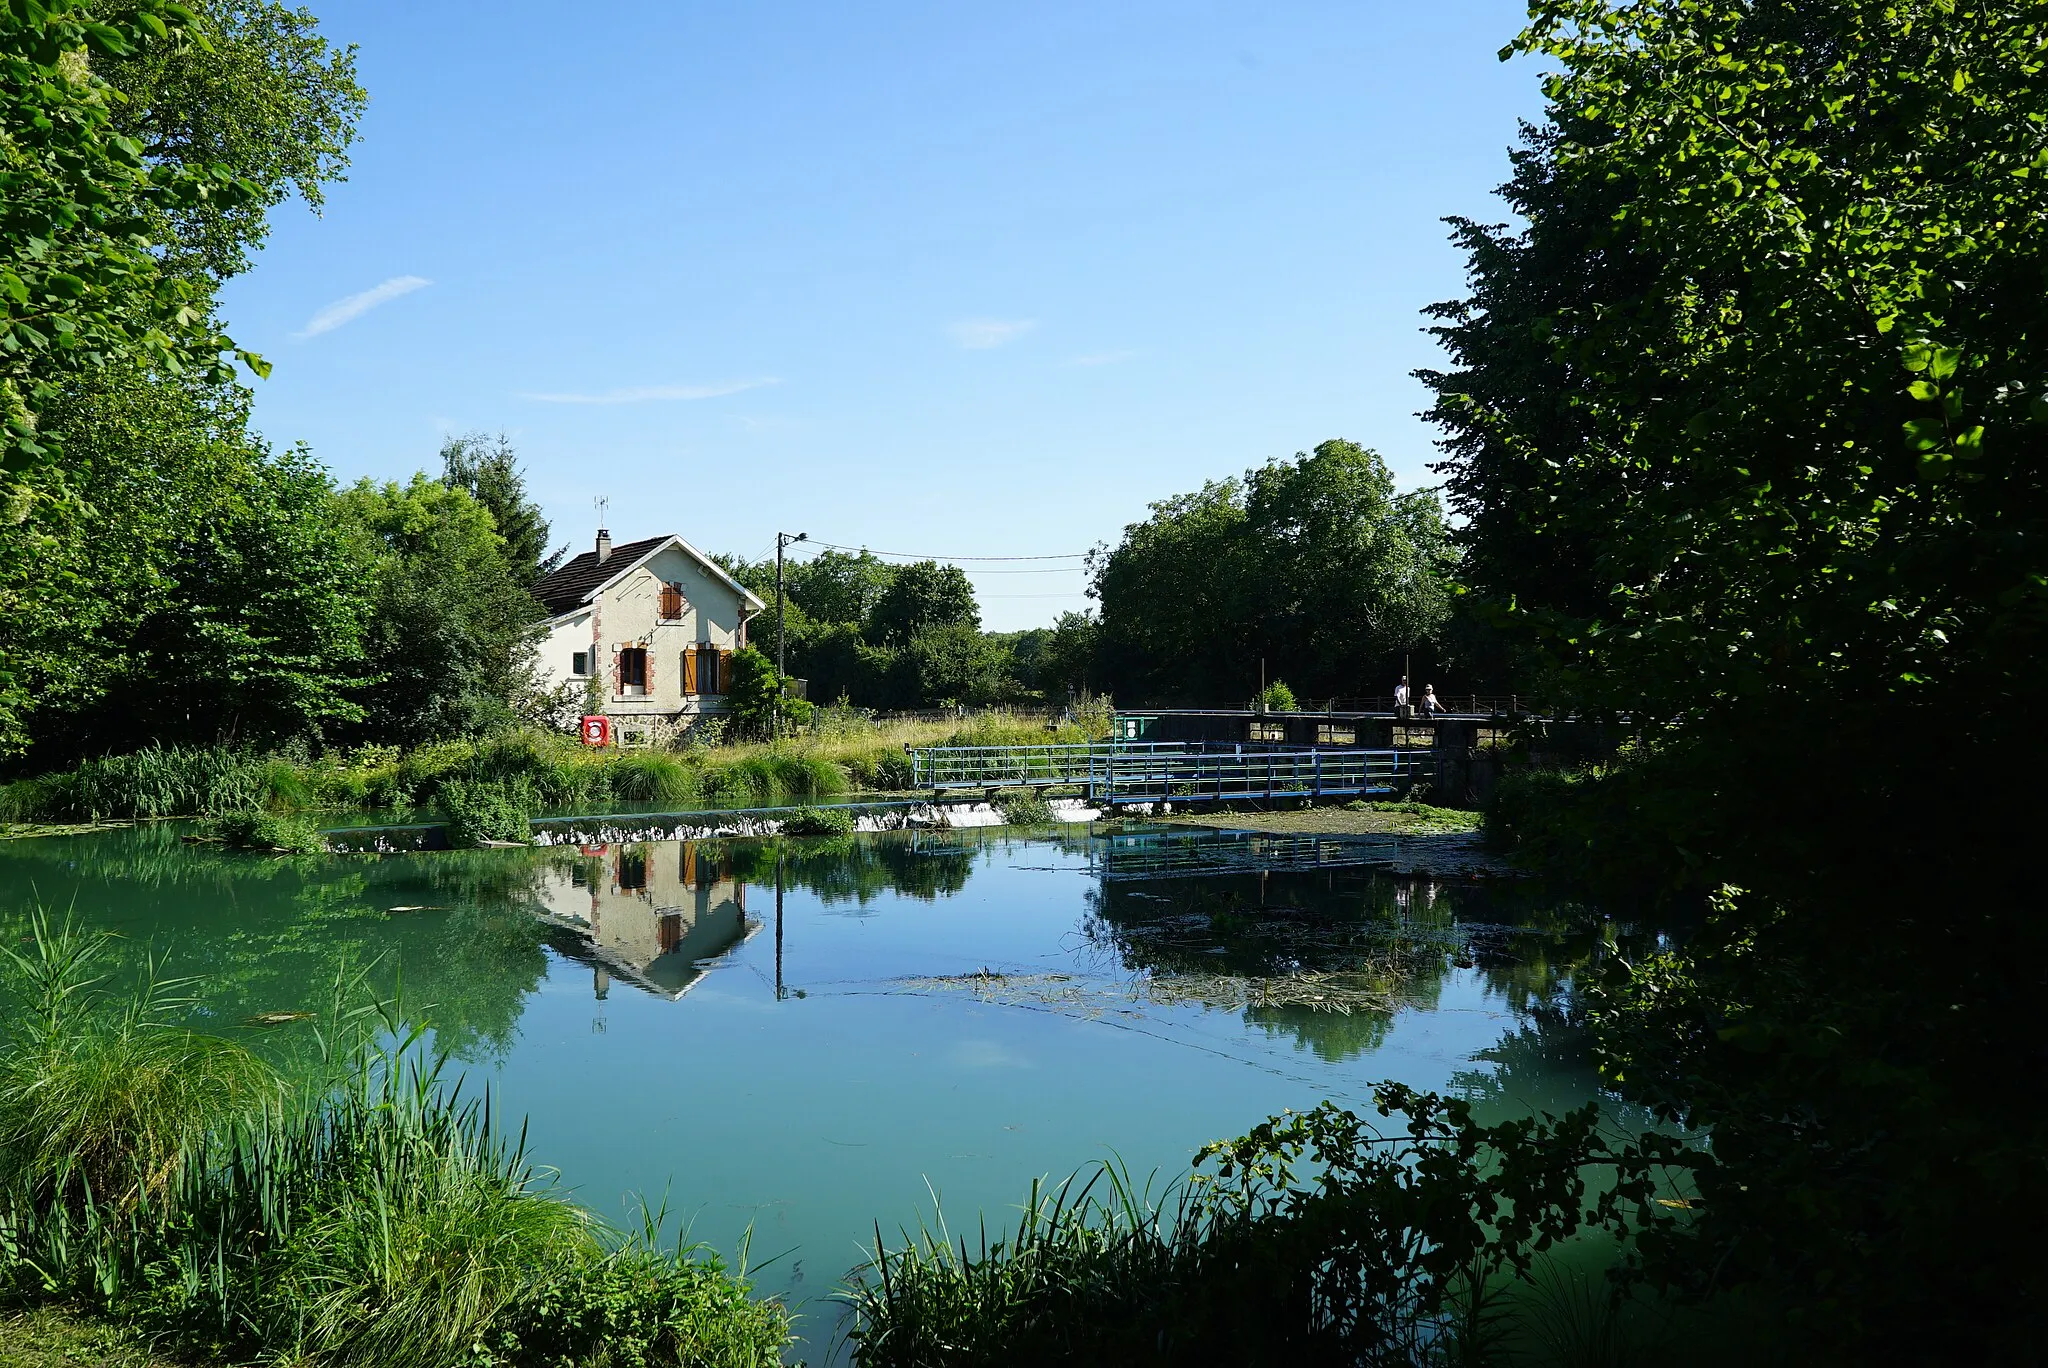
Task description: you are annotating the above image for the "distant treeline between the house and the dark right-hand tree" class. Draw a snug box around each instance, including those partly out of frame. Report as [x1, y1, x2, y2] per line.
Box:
[723, 440, 1474, 709]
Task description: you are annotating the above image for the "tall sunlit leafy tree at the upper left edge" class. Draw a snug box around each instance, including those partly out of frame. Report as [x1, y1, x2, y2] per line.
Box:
[0, 0, 362, 754]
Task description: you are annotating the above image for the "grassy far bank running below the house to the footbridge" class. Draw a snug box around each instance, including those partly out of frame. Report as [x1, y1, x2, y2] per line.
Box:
[0, 709, 1106, 844]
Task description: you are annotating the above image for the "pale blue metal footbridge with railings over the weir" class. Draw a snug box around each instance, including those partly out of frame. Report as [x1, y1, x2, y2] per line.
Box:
[909, 741, 1423, 807]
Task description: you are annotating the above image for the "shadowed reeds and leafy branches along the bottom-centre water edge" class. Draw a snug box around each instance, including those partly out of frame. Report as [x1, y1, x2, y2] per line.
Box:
[848, 1083, 1710, 1368]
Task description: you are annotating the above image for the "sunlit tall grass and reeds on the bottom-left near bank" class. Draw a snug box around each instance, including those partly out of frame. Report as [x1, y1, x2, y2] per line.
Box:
[0, 920, 788, 1368]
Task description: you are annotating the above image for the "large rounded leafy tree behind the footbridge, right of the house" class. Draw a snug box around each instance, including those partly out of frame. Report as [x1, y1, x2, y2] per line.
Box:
[1094, 440, 1454, 702]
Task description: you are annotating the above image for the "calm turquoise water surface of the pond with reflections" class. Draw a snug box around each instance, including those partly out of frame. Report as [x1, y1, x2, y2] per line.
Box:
[0, 827, 1614, 1356]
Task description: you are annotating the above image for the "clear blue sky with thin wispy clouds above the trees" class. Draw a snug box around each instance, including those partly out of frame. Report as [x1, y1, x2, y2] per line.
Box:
[225, 0, 1540, 629]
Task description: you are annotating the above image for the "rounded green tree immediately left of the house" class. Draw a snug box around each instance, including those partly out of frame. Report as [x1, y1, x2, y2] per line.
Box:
[336, 475, 543, 743]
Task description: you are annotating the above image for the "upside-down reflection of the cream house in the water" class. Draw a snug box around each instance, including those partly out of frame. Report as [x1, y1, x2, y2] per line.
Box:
[541, 842, 762, 1001]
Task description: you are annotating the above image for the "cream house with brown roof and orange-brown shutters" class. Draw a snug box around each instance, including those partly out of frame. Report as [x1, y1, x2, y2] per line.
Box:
[532, 530, 766, 745]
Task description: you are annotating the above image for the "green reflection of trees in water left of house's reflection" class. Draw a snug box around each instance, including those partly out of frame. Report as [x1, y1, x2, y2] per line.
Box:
[0, 825, 557, 1059]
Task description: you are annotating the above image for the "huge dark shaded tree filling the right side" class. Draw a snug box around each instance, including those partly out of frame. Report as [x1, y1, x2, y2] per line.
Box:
[1423, 0, 2048, 1362]
